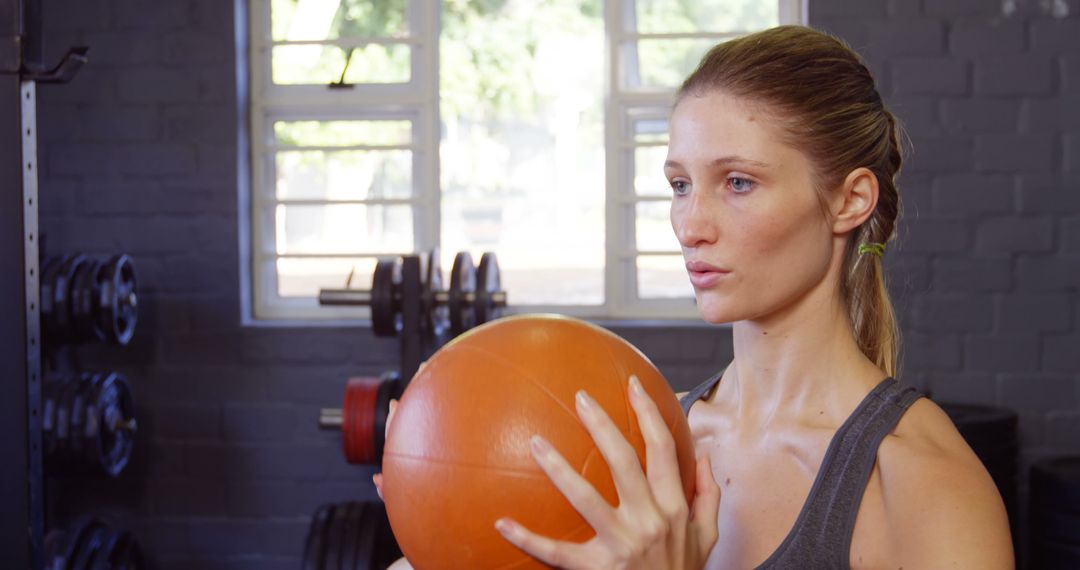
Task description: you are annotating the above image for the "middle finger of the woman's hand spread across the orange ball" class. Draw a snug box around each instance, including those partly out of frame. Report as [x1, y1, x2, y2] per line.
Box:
[575, 390, 652, 506]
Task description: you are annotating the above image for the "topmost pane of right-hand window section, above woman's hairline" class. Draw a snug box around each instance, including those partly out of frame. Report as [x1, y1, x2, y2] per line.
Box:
[630, 0, 780, 33]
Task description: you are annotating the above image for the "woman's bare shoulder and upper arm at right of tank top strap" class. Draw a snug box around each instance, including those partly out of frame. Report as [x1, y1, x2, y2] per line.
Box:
[878, 398, 1013, 568]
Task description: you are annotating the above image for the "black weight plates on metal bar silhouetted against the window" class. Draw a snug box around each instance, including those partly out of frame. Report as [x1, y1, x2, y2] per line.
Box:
[319, 249, 507, 337]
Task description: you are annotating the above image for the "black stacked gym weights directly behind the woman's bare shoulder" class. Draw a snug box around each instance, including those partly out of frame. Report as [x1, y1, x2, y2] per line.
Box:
[939, 403, 1020, 542]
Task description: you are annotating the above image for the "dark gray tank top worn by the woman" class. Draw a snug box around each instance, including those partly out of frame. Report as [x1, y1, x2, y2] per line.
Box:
[679, 371, 922, 570]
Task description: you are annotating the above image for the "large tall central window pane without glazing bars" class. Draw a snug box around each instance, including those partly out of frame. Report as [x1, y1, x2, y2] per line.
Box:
[440, 0, 605, 306]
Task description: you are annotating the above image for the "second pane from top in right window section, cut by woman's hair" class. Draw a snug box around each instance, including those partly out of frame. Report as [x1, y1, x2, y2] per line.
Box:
[622, 38, 716, 89]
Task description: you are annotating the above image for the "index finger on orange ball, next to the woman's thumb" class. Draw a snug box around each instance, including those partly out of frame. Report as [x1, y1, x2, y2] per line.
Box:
[630, 376, 689, 518]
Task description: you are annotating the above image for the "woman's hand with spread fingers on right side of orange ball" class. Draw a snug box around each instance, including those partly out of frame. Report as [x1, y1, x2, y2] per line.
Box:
[496, 377, 720, 570]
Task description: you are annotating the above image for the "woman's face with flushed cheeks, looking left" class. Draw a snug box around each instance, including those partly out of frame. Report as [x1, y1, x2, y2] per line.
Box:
[664, 91, 834, 323]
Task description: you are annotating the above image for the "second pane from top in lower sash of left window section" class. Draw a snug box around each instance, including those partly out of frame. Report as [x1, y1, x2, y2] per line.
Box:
[275, 150, 413, 200]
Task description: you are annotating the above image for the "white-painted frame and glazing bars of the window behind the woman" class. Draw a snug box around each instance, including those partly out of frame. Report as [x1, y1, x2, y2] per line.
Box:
[241, 0, 807, 324]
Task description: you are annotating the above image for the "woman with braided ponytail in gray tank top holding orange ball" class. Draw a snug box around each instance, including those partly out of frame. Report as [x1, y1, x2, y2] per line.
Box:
[382, 26, 1013, 569]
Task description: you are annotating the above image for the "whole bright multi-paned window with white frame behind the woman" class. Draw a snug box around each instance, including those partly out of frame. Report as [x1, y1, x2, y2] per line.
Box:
[249, 0, 804, 320]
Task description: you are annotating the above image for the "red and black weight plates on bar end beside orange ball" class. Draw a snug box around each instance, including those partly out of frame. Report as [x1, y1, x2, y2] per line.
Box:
[319, 371, 404, 465]
